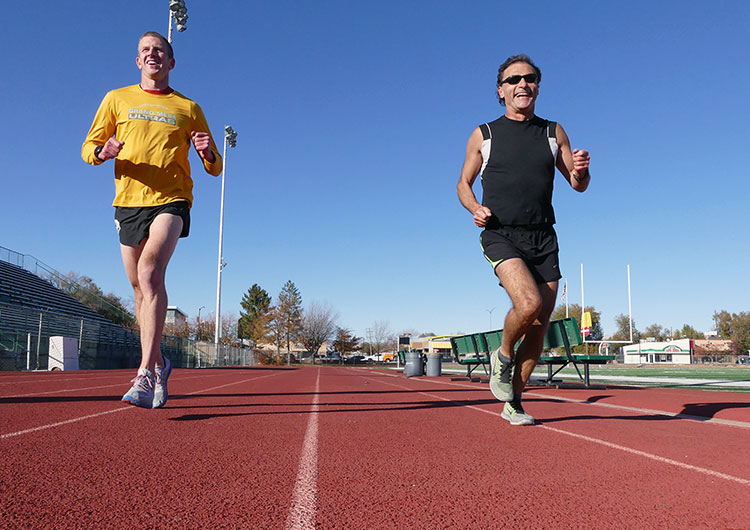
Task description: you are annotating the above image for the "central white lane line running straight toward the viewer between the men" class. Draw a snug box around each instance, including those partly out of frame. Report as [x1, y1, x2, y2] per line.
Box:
[286, 368, 320, 530]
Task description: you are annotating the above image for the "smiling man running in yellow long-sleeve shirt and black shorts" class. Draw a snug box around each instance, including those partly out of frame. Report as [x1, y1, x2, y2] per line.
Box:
[81, 32, 222, 408]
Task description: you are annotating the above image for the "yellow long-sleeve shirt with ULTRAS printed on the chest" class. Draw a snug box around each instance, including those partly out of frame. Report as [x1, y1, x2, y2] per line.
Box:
[81, 85, 222, 207]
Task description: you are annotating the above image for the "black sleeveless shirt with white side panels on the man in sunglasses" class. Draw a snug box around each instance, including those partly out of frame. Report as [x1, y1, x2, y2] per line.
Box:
[479, 116, 557, 228]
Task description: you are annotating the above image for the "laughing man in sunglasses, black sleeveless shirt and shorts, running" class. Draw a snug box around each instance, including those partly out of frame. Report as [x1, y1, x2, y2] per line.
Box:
[458, 55, 591, 425]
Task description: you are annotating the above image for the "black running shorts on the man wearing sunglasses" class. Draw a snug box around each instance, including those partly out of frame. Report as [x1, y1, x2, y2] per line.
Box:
[480, 225, 562, 284]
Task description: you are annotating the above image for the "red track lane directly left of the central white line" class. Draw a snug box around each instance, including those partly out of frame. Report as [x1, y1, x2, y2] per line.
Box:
[0, 370, 314, 528]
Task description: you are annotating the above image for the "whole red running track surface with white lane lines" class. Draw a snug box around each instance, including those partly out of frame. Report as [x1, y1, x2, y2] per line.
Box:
[0, 367, 750, 530]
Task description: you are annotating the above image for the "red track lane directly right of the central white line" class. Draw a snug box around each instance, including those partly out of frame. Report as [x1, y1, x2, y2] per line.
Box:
[319, 368, 750, 528]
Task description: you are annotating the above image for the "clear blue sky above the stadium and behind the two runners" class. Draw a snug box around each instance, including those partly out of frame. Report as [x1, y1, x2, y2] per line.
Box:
[0, 0, 750, 335]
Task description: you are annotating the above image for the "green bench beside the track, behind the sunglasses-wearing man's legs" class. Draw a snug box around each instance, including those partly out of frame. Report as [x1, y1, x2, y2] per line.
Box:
[451, 317, 615, 388]
